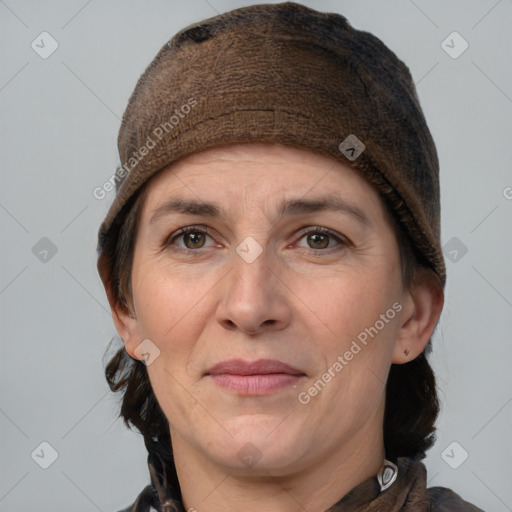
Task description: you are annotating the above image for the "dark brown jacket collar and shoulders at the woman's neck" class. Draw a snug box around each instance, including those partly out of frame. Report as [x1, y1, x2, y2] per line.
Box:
[120, 456, 483, 512]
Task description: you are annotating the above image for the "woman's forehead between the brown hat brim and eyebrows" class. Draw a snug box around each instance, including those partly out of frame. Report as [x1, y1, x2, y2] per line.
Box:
[140, 143, 383, 216]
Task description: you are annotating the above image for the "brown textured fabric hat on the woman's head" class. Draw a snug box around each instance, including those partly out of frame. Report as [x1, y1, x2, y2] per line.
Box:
[98, 2, 446, 286]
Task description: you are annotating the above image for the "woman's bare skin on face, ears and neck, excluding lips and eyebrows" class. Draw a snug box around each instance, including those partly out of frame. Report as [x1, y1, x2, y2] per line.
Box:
[111, 144, 443, 512]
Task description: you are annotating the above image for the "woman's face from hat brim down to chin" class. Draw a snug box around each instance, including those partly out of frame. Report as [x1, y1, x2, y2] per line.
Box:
[125, 144, 407, 475]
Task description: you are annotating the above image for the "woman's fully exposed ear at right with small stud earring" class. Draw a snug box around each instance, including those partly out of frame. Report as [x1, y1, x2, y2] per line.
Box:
[392, 269, 444, 364]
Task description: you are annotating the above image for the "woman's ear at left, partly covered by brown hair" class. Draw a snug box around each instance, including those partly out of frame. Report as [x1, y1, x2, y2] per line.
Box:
[98, 253, 142, 360]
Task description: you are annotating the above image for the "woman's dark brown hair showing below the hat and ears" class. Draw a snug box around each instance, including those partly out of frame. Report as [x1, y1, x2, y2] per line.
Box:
[98, 174, 440, 471]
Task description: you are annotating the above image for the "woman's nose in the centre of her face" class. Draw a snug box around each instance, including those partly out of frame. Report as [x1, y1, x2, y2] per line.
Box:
[216, 245, 291, 335]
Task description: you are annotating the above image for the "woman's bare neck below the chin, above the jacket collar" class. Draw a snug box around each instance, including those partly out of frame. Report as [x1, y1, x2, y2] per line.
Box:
[171, 404, 385, 512]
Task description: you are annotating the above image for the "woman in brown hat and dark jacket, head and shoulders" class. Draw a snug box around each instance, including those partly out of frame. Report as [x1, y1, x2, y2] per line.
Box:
[98, 2, 480, 512]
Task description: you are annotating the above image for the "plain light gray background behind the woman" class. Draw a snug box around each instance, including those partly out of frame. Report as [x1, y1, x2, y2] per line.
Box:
[0, 0, 512, 512]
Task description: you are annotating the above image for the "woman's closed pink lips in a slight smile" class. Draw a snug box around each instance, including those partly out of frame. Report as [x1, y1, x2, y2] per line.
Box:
[205, 359, 306, 396]
